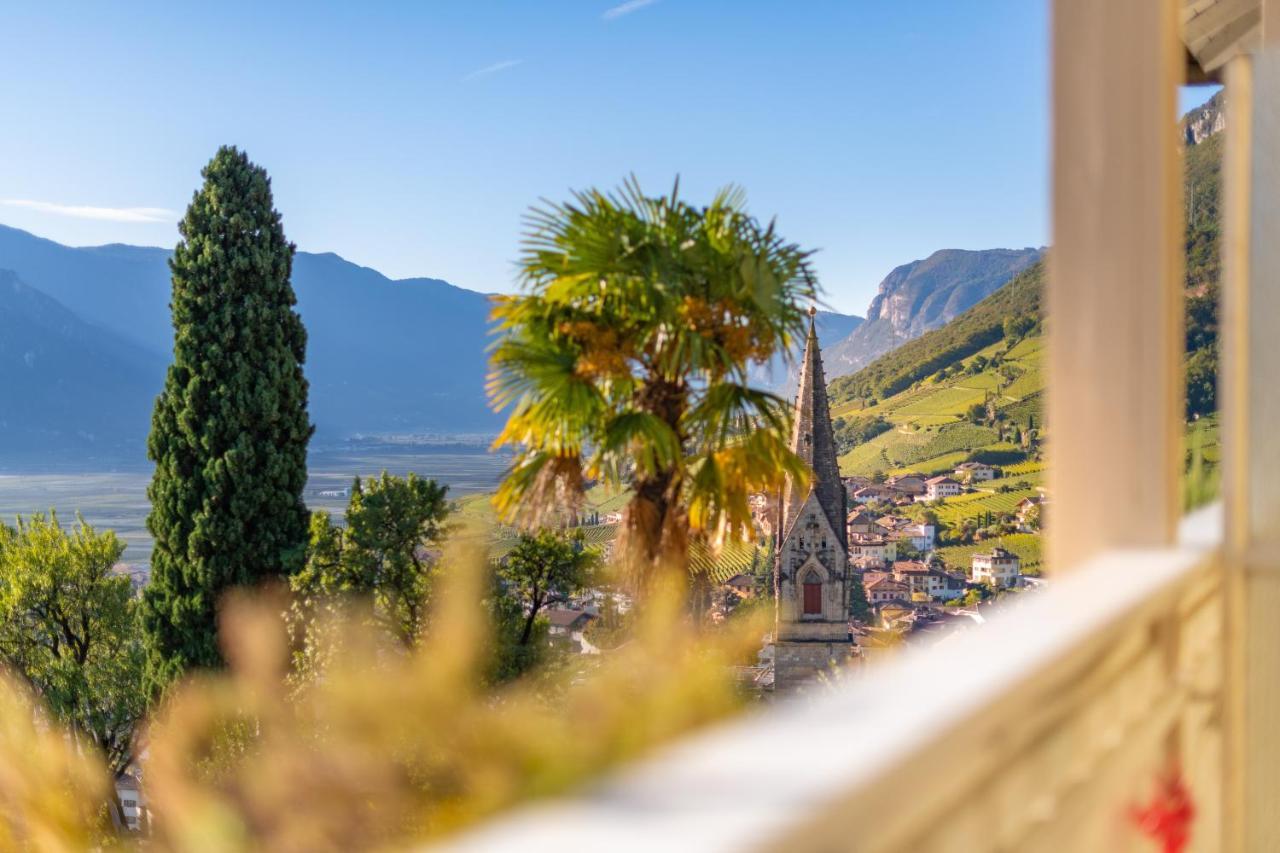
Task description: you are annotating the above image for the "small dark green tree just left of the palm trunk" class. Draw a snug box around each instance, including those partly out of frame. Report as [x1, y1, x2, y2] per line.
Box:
[498, 530, 600, 646]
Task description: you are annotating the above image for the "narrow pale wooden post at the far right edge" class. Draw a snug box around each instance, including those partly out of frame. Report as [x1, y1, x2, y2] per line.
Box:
[1221, 0, 1280, 835]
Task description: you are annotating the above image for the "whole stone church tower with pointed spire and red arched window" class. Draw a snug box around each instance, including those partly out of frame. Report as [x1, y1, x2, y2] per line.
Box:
[773, 309, 851, 690]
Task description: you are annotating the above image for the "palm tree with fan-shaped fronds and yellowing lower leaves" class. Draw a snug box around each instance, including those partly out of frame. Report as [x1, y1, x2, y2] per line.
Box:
[489, 178, 817, 587]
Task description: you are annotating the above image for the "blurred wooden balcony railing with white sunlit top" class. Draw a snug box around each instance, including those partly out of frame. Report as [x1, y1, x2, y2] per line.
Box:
[451, 507, 1225, 853]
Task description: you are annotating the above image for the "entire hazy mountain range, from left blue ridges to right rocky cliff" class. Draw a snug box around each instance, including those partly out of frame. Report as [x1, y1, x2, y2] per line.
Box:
[0, 219, 1039, 465]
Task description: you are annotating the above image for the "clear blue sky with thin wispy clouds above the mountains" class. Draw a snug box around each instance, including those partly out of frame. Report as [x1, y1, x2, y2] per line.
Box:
[0, 0, 1218, 314]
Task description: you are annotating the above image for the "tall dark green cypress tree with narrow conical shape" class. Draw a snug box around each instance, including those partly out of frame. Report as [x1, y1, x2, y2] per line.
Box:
[143, 147, 312, 690]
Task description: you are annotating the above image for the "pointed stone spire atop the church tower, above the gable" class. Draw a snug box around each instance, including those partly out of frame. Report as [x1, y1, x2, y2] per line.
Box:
[781, 307, 847, 549]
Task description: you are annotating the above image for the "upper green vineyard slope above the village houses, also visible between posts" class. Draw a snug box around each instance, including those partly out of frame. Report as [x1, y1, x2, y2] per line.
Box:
[829, 120, 1222, 474]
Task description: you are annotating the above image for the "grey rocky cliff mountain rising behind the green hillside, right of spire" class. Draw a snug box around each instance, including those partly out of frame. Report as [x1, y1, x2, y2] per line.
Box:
[823, 248, 1044, 379]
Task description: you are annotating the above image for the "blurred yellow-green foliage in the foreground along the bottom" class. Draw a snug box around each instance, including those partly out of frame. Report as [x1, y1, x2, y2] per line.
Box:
[0, 546, 764, 852]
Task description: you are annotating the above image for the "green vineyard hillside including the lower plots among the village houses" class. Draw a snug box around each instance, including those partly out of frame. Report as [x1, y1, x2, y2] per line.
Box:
[828, 114, 1222, 558]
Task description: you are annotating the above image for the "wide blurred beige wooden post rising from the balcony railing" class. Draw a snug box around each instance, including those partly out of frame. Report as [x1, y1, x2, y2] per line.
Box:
[1047, 0, 1185, 573]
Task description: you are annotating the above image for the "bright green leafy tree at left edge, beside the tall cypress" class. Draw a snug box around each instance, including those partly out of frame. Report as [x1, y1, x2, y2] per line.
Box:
[0, 515, 147, 775]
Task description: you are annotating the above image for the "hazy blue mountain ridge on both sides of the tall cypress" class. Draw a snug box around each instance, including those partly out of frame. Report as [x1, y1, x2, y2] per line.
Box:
[0, 219, 500, 462]
